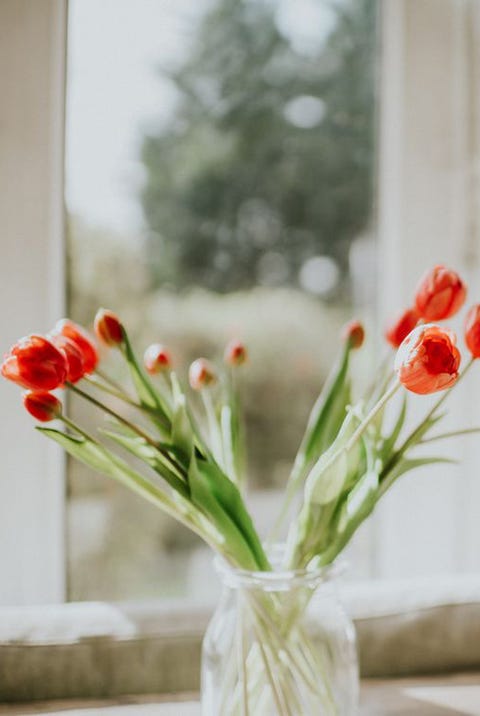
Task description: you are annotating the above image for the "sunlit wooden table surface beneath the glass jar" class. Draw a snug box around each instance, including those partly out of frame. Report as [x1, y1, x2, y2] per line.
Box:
[0, 674, 480, 716]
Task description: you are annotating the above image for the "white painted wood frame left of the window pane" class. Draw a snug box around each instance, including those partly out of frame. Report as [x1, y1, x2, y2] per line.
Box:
[0, 0, 67, 604]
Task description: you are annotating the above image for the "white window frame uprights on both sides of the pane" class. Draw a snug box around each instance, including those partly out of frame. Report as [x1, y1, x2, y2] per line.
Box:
[0, 0, 480, 605]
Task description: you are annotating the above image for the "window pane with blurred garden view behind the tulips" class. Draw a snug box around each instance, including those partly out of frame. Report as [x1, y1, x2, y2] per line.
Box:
[67, 0, 376, 599]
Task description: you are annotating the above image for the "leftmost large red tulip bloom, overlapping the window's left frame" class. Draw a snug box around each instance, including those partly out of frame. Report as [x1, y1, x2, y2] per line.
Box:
[1, 335, 68, 390]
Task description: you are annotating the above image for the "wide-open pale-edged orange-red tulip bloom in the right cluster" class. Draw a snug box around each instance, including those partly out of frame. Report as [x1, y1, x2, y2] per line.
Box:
[395, 324, 461, 395]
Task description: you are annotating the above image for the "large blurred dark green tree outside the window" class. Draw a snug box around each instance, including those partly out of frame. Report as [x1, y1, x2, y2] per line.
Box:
[142, 0, 376, 297]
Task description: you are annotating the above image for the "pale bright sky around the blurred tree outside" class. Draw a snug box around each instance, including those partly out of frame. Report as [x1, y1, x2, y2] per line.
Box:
[66, 0, 333, 238]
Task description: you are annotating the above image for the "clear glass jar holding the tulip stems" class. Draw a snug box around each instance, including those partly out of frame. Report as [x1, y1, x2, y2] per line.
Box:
[202, 547, 359, 716]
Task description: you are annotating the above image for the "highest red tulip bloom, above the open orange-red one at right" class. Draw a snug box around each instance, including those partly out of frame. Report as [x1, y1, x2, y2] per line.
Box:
[415, 265, 467, 321]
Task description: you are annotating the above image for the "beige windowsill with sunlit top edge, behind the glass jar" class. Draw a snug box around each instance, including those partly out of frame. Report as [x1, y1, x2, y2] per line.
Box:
[0, 575, 480, 713]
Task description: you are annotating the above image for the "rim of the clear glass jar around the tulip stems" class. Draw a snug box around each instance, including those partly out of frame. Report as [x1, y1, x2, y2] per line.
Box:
[214, 543, 347, 592]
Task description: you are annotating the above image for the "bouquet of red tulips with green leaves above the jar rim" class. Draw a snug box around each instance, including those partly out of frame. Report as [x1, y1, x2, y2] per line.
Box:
[1, 266, 480, 713]
